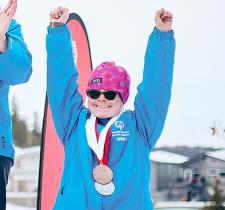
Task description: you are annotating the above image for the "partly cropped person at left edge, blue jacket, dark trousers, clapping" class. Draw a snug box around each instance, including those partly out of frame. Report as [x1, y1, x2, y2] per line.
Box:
[0, 0, 32, 210]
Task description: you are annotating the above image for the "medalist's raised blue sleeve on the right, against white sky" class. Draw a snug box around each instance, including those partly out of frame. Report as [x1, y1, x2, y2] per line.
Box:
[134, 27, 175, 150]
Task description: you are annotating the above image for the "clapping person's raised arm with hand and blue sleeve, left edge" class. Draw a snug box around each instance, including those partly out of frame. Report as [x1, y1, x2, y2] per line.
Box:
[0, 0, 32, 85]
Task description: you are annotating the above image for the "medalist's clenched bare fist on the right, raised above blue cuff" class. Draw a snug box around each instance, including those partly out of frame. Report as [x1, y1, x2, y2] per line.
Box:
[155, 8, 173, 32]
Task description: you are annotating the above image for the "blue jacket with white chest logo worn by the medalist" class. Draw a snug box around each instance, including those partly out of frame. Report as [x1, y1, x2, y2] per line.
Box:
[46, 25, 175, 210]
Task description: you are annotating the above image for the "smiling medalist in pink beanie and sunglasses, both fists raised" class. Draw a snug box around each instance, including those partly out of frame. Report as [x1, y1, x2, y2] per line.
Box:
[46, 7, 175, 210]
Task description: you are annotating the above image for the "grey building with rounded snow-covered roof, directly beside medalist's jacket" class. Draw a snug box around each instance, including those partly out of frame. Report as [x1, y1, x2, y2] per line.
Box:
[150, 150, 189, 201]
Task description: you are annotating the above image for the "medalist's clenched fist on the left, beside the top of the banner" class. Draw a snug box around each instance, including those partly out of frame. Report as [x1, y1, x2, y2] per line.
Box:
[50, 7, 69, 24]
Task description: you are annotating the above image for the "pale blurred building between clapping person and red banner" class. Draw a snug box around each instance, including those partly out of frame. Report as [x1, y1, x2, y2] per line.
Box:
[7, 146, 40, 206]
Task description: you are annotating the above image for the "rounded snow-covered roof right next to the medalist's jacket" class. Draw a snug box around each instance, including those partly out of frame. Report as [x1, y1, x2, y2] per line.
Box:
[150, 150, 189, 164]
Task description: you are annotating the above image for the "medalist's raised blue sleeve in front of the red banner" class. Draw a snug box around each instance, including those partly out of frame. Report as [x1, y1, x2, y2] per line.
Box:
[46, 25, 83, 145]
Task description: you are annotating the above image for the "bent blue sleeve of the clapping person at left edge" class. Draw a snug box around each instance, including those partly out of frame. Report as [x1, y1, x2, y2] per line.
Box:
[0, 20, 32, 85]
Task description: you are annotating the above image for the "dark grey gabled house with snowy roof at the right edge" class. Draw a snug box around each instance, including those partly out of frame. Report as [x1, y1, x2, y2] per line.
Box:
[180, 149, 225, 201]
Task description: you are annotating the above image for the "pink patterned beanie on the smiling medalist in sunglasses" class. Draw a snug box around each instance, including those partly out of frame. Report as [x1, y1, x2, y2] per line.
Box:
[87, 62, 130, 103]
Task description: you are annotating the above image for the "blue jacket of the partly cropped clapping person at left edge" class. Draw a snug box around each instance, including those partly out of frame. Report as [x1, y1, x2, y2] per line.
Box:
[0, 20, 32, 160]
